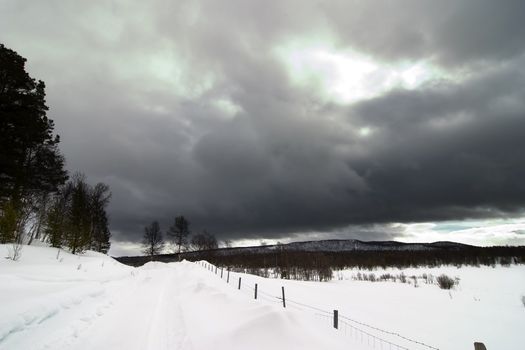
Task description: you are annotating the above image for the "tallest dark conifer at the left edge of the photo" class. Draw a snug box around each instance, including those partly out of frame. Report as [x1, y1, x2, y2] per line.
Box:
[0, 44, 67, 241]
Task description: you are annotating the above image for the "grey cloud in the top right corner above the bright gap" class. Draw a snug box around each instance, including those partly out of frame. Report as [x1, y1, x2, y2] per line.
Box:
[322, 0, 525, 66]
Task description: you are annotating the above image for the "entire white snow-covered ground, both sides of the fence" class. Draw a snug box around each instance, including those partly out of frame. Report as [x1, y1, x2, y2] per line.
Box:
[0, 245, 525, 350]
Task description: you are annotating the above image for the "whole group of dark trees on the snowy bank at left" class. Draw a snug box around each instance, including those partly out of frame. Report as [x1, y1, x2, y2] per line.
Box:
[0, 44, 111, 260]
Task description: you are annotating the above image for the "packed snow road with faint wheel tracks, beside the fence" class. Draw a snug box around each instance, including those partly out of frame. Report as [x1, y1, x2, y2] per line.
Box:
[73, 266, 192, 349]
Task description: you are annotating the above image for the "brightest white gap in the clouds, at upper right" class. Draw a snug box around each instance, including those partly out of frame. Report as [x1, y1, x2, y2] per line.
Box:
[275, 44, 446, 103]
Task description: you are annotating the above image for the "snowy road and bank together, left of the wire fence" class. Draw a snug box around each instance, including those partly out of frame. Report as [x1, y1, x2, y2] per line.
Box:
[0, 247, 361, 350]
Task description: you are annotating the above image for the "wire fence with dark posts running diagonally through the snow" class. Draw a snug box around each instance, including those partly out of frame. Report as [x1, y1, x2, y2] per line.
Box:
[192, 261, 439, 350]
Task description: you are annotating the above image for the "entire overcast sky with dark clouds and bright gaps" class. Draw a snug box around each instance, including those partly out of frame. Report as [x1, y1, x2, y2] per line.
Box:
[0, 0, 525, 255]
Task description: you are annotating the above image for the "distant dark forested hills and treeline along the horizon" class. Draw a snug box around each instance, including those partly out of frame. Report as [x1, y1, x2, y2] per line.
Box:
[117, 246, 525, 281]
